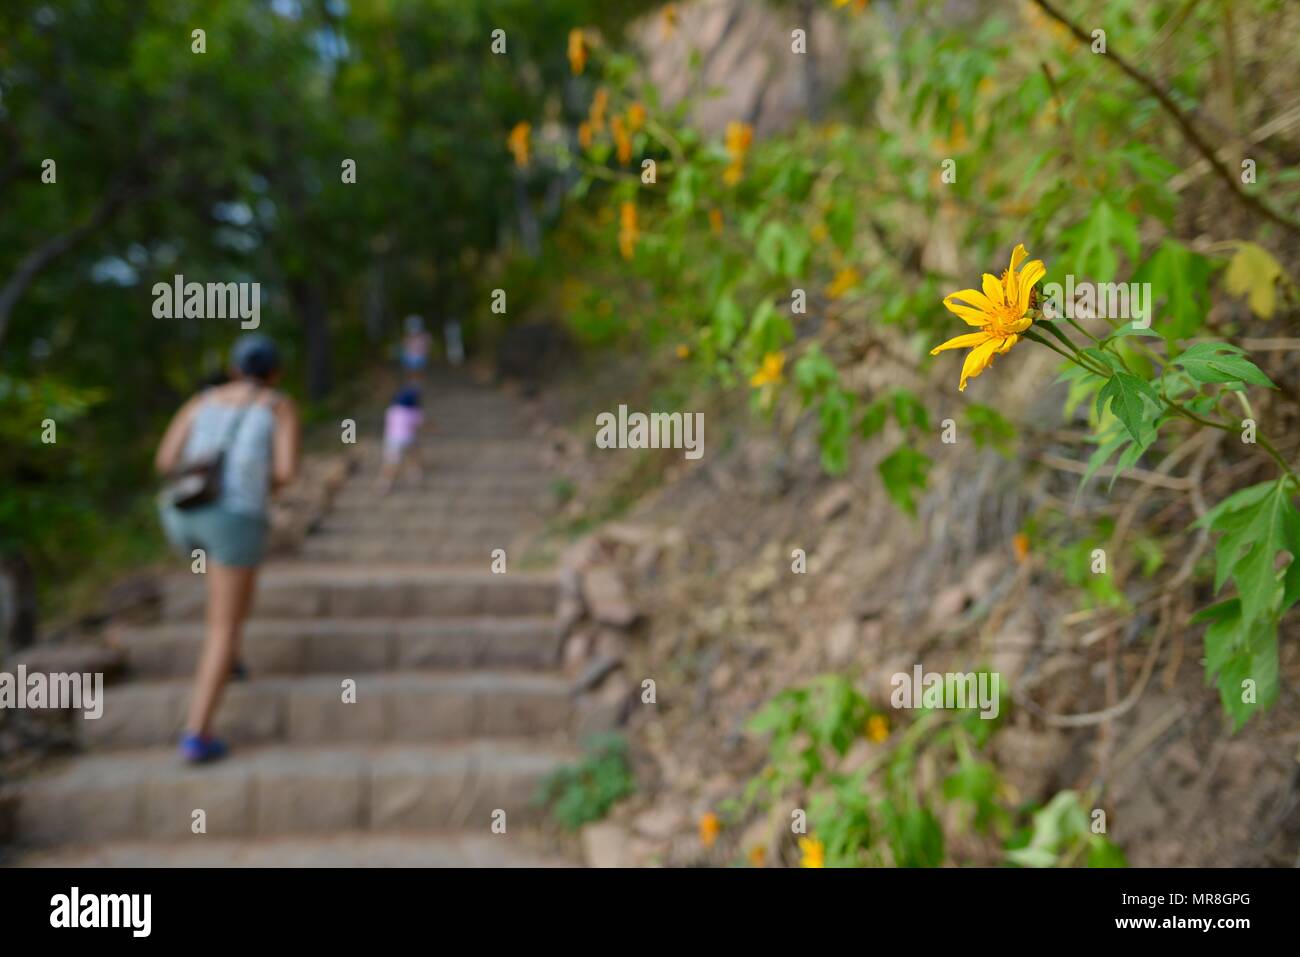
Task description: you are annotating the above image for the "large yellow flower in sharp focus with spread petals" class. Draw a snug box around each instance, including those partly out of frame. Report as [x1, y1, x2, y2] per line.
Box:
[930, 243, 1047, 391]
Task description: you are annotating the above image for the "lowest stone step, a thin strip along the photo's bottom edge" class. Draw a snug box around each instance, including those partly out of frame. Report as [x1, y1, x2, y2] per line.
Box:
[9, 832, 575, 867]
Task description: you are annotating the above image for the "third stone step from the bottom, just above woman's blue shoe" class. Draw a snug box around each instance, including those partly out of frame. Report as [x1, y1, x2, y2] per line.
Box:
[75, 671, 573, 750]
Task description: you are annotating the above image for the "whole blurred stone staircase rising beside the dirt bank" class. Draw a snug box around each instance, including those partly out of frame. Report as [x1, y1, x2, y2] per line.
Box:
[7, 381, 579, 866]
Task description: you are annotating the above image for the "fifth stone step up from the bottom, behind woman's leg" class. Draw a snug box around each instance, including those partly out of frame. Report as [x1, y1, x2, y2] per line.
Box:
[163, 558, 556, 622]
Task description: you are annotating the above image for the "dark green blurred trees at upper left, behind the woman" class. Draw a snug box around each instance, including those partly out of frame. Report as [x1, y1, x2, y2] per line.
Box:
[0, 0, 646, 605]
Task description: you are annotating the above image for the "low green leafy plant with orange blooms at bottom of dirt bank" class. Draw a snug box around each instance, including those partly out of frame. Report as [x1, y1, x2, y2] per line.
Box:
[725, 675, 1123, 867]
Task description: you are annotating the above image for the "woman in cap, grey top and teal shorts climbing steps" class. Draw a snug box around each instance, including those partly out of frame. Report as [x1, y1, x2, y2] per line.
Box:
[155, 334, 302, 762]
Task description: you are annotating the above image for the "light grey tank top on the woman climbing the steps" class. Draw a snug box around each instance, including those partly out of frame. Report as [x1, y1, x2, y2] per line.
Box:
[183, 399, 276, 515]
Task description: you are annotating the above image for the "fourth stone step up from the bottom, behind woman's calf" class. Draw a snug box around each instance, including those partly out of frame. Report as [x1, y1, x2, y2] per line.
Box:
[117, 615, 560, 679]
